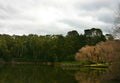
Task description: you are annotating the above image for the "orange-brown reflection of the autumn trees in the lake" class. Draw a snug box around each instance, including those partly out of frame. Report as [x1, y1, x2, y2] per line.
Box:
[75, 70, 104, 83]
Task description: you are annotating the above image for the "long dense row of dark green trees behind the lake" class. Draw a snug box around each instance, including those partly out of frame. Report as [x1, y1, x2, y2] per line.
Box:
[0, 28, 106, 62]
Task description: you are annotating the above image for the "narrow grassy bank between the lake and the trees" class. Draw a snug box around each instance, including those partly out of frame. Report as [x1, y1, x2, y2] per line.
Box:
[0, 59, 109, 68]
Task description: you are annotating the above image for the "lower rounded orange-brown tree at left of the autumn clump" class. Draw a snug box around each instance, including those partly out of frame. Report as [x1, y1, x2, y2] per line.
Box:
[75, 46, 99, 62]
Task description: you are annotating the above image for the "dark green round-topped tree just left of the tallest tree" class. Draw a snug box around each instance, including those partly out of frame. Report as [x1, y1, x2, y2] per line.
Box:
[64, 30, 80, 57]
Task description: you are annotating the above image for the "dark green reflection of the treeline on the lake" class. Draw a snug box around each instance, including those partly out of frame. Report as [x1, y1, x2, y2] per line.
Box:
[0, 65, 77, 83]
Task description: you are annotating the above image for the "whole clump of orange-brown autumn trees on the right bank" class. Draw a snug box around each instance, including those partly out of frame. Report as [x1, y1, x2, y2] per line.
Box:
[75, 40, 120, 64]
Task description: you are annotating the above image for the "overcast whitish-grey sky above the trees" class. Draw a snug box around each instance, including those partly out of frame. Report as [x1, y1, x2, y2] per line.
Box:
[0, 0, 120, 35]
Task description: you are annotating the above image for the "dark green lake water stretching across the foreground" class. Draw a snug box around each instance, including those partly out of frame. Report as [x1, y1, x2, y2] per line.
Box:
[0, 65, 120, 83]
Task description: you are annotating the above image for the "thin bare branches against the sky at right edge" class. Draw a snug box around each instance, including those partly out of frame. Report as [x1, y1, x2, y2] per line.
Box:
[113, 4, 120, 39]
